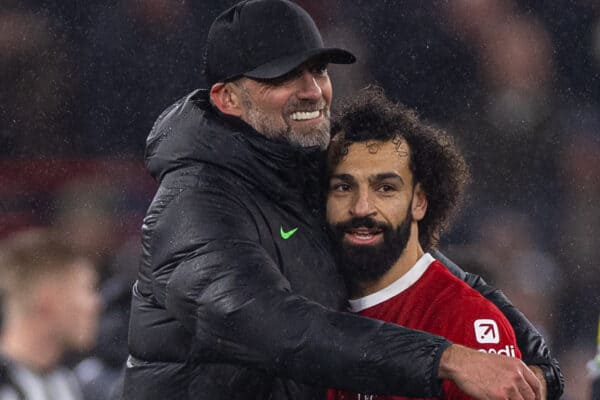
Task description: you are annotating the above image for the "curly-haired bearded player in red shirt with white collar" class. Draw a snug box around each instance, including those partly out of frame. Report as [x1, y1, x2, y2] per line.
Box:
[327, 89, 521, 400]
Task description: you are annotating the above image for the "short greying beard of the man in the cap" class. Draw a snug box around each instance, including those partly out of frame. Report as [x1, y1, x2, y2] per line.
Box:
[240, 86, 331, 150]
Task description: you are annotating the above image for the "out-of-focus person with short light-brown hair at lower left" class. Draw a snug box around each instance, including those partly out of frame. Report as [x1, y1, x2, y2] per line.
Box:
[0, 230, 100, 400]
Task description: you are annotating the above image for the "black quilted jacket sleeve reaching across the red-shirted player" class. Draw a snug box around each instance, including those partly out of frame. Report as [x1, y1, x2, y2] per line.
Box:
[152, 188, 450, 397]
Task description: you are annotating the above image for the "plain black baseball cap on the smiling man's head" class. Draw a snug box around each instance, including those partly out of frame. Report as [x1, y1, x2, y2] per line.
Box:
[204, 0, 356, 85]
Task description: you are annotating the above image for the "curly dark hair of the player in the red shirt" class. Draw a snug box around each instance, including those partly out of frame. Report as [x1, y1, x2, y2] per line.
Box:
[328, 86, 470, 249]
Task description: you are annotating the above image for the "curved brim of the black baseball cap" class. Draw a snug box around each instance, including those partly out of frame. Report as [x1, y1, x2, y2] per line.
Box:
[242, 48, 356, 79]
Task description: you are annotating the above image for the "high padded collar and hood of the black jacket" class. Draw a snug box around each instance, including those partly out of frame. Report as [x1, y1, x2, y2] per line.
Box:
[146, 90, 325, 209]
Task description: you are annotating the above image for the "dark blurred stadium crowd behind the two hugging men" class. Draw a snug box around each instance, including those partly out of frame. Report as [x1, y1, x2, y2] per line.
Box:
[0, 0, 600, 399]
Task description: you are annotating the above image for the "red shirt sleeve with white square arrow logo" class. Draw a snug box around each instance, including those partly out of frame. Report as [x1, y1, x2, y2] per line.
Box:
[443, 296, 521, 400]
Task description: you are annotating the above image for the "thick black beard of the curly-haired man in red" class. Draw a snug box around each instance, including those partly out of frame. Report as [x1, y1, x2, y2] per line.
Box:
[328, 207, 411, 295]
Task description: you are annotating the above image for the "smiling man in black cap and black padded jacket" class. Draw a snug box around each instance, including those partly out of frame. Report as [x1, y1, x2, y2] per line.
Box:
[124, 0, 560, 400]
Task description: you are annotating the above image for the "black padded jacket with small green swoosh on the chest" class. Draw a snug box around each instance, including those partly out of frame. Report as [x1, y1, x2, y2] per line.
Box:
[123, 91, 564, 400]
